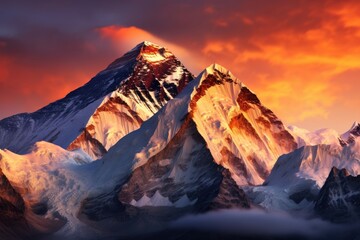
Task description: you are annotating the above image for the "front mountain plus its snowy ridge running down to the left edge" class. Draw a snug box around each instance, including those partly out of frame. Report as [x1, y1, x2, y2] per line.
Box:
[0, 64, 297, 235]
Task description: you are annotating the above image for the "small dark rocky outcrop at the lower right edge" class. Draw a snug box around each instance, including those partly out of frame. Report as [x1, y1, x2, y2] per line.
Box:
[315, 167, 360, 222]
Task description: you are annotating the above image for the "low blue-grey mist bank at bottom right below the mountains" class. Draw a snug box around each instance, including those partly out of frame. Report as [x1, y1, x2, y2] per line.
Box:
[170, 210, 356, 239]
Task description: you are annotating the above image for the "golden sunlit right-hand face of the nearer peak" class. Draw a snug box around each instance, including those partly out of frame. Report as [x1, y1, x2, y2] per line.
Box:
[190, 64, 296, 185]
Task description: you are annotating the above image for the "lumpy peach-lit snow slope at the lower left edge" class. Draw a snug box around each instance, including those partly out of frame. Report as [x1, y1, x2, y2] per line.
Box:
[0, 142, 92, 237]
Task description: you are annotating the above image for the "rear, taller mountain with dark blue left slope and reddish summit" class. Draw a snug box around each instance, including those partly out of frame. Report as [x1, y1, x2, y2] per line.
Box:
[0, 41, 193, 159]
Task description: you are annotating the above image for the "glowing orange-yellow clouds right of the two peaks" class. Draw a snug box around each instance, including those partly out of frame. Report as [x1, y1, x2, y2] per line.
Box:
[183, 1, 360, 131]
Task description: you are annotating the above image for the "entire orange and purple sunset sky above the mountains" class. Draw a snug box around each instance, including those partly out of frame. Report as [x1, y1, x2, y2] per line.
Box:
[0, 0, 360, 132]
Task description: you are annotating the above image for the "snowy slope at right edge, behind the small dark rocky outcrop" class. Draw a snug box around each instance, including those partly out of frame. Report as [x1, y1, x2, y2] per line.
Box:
[265, 138, 360, 201]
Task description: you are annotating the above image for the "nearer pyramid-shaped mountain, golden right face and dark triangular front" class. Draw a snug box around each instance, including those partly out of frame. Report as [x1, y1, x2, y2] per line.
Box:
[81, 64, 296, 223]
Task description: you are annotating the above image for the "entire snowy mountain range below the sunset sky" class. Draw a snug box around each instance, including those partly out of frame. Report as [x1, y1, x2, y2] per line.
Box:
[0, 41, 360, 239]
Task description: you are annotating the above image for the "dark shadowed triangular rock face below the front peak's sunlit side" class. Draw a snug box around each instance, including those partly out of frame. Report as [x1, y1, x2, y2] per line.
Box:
[119, 119, 250, 211]
